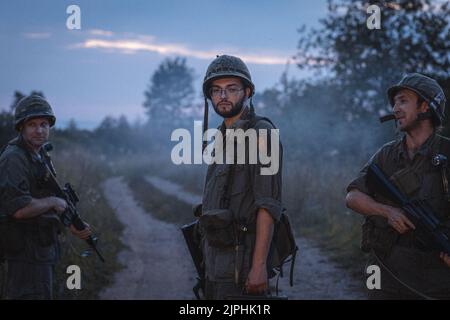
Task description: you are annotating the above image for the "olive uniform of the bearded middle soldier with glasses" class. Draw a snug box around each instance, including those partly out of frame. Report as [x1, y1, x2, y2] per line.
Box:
[200, 109, 282, 299]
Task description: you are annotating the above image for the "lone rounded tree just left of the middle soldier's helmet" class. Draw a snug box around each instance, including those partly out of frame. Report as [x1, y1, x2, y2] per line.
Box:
[144, 57, 195, 121]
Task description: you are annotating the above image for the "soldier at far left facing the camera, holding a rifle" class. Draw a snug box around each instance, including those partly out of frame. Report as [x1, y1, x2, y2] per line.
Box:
[0, 95, 91, 299]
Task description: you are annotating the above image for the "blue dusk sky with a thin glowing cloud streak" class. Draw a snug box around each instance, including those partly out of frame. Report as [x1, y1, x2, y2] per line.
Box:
[0, 0, 326, 129]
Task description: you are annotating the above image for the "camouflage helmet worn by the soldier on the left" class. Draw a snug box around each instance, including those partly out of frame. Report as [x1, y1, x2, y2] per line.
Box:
[14, 94, 56, 131]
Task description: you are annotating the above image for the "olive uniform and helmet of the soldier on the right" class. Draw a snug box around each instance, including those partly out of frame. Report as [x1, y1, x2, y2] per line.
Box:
[347, 74, 450, 299]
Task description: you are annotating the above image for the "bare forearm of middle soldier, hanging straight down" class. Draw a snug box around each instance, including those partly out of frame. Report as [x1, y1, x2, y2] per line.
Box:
[252, 208, 273, 266]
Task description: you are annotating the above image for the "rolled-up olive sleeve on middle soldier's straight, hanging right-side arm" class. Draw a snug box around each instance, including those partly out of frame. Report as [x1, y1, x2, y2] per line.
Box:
[251, 121, 283, 221]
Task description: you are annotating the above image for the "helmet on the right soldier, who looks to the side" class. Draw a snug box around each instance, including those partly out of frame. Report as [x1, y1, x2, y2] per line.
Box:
[388, 73, 446, 125]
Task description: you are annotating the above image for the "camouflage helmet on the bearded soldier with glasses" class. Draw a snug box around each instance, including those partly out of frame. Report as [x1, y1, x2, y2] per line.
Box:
[203, 55, 255, 98]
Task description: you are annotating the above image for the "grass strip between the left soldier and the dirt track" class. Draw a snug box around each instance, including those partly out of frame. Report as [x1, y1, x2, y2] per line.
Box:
[48, 148, 123, 299]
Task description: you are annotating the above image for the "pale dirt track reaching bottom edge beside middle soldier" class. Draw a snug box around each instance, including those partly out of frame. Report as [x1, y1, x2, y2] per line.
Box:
[100, 178, 195, 299]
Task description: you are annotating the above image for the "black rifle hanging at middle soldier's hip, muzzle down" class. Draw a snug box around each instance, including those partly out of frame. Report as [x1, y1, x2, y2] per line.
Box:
[181, 220, 205, 300]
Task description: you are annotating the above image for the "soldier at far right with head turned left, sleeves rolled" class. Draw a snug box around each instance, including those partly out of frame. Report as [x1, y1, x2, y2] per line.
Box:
[346, 73, 450, 299]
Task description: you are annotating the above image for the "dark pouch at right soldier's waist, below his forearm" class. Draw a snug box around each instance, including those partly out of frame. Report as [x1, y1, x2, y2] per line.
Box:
[361, 216, 399, 257]
